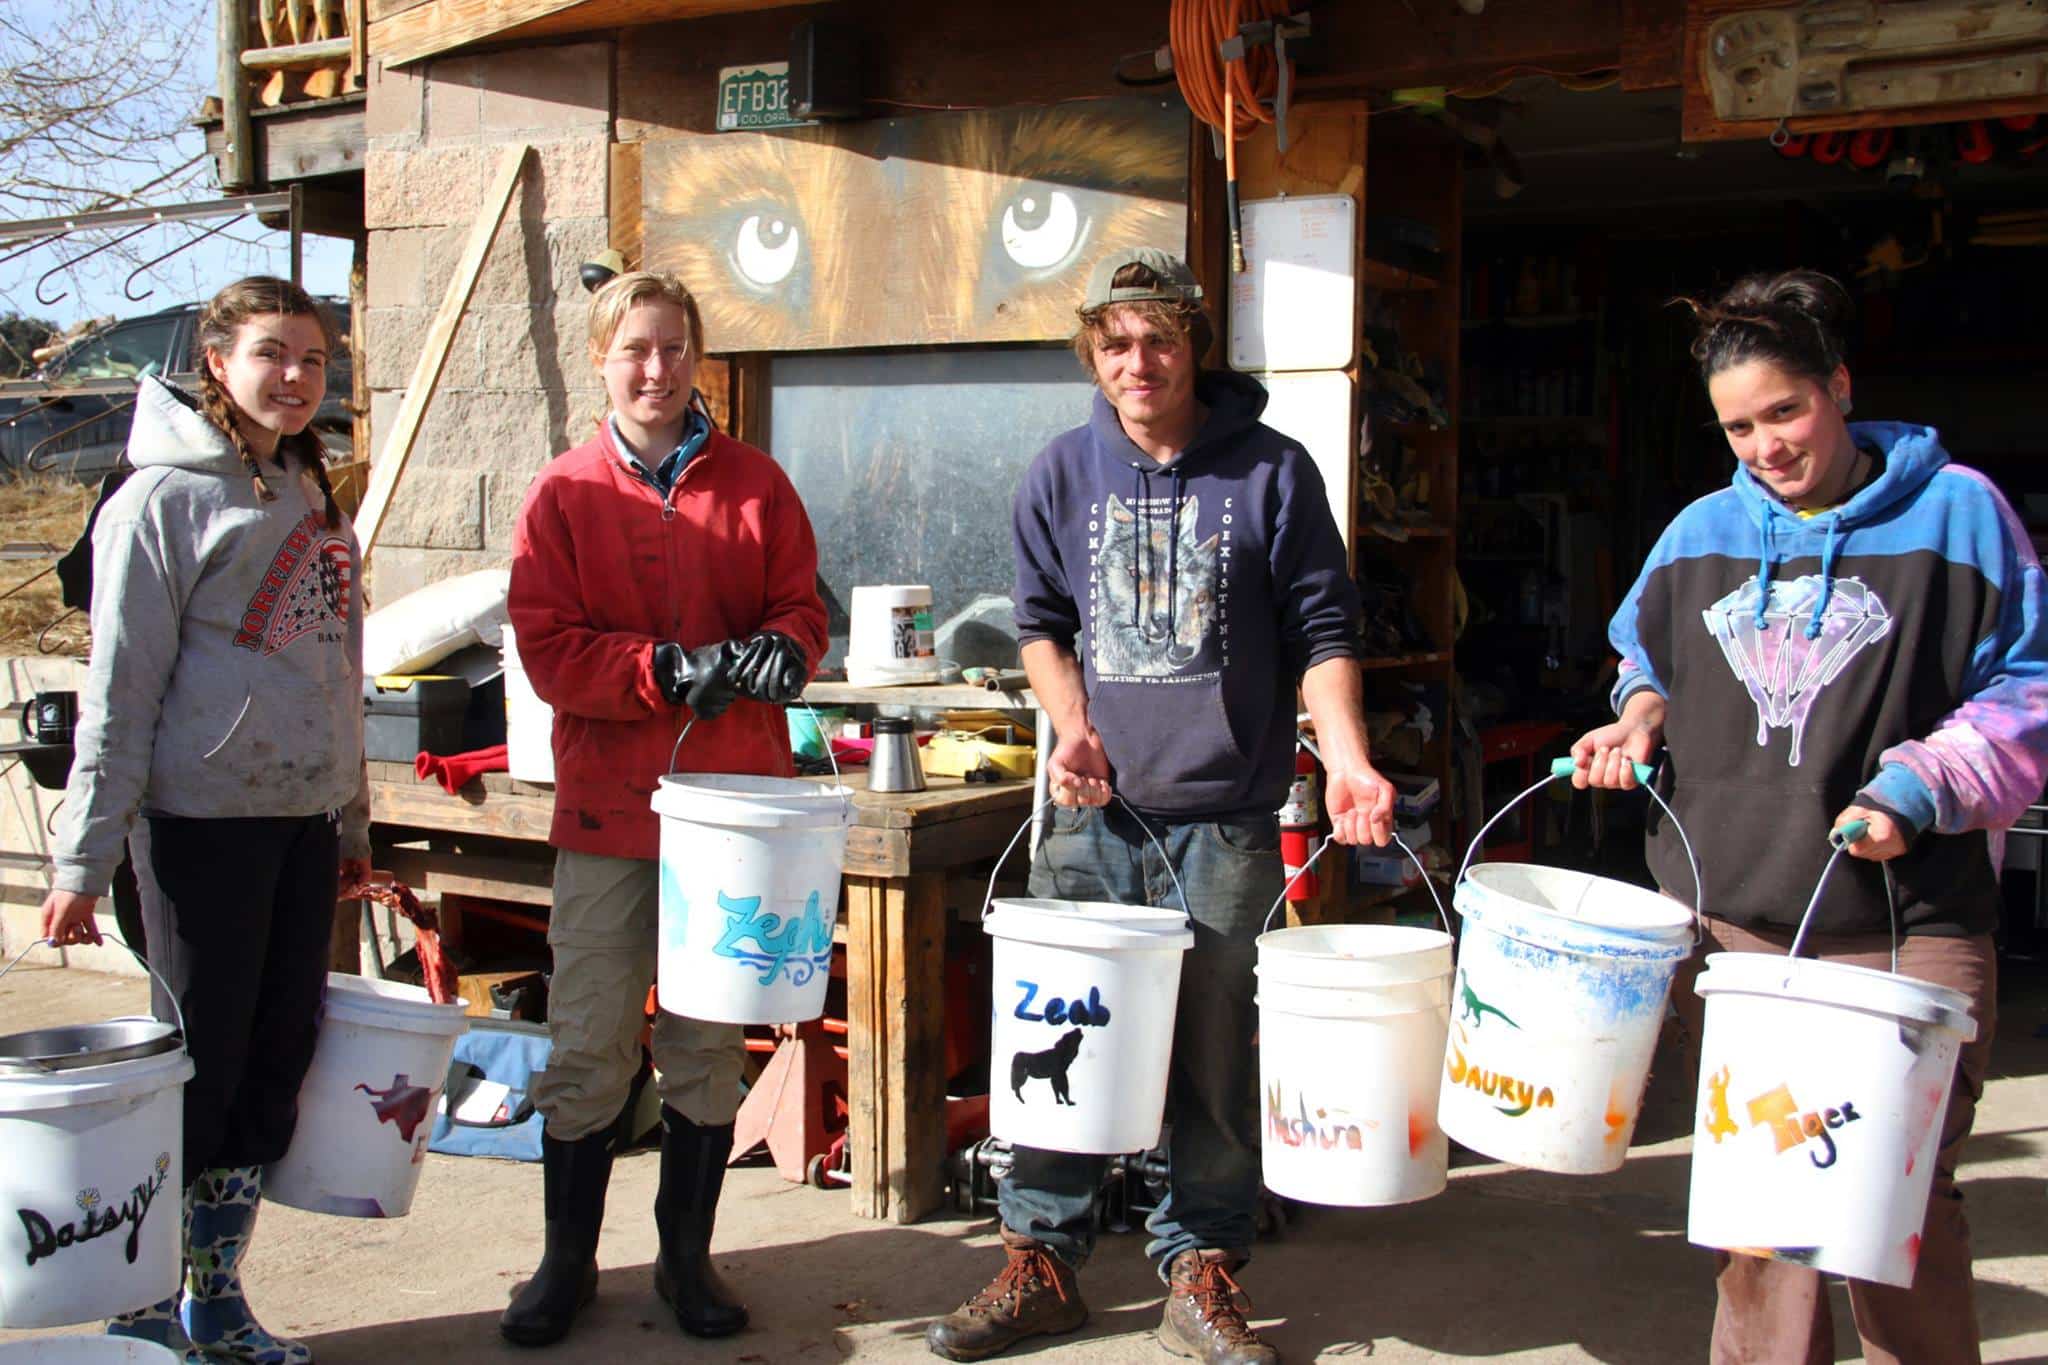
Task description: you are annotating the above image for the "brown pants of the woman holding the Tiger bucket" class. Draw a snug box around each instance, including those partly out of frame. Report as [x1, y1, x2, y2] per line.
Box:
[1671, 919, 1997, 1365]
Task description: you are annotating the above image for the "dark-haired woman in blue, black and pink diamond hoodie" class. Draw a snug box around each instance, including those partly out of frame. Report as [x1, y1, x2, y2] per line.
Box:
[1573, 270, 2048, 1365]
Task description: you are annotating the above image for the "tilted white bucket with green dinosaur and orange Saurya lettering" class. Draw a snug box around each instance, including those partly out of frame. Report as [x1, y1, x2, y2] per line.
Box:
[1438, 864, 1694, 1175]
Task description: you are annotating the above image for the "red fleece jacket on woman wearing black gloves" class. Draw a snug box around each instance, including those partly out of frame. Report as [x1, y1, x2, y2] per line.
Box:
[508, 424, 825, 857]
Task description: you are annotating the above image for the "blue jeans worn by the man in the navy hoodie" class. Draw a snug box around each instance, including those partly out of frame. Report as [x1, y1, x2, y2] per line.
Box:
[999, 804, 1282, 1279]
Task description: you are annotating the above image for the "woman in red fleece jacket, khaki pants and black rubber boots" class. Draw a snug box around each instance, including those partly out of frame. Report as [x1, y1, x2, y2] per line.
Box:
[498, 272, 825, 1347]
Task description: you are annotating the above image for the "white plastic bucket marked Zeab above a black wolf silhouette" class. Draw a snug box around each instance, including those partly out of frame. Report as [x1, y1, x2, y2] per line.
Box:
[981, 898, 1194, 1156]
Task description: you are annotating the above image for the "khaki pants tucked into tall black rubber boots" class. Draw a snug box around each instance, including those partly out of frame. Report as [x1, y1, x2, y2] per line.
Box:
[532, 849, 745, 1142]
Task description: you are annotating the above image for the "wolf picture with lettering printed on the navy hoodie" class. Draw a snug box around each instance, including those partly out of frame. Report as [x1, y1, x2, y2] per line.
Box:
[1092, 493, 1229, 677]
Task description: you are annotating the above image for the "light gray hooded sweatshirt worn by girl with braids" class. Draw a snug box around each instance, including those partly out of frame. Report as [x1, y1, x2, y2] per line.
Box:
[55, 379, 369, 894]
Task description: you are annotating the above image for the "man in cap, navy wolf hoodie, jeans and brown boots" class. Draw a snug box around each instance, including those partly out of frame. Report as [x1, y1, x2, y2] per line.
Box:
[926, 248, 1393, 1363]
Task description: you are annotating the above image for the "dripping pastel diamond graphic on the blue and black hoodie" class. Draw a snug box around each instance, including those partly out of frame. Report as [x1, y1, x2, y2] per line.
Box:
[1700, 573, 1892, 767]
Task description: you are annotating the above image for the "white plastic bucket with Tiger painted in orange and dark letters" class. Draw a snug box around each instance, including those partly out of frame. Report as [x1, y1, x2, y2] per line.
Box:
[1686, 954, 1976, 1289]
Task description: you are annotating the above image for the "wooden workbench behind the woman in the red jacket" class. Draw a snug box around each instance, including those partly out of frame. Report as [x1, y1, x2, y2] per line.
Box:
[369, 763, 1032, 1222]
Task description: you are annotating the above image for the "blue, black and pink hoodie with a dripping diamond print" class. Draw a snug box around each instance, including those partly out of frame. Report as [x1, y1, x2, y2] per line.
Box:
[1608, 422, 2048, 935]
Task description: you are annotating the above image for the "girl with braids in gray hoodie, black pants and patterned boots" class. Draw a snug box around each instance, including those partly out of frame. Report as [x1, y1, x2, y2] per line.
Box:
[43, 276, 369, 1365]
